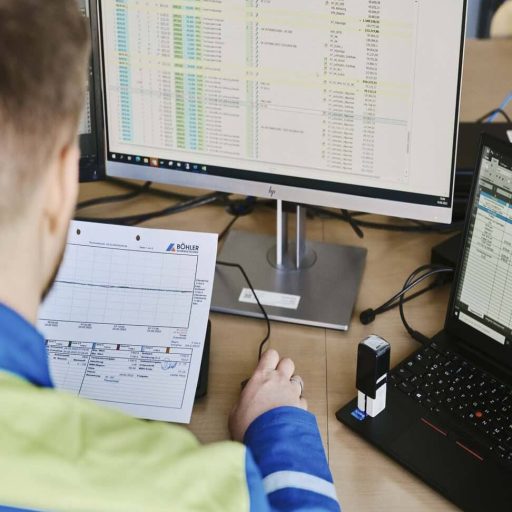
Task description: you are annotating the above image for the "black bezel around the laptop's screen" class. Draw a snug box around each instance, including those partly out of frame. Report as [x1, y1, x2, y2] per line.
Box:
[445, 133, 512, 369]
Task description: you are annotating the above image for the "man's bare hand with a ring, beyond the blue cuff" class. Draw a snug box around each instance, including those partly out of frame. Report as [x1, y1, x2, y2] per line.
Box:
[229, 349, 308, 442]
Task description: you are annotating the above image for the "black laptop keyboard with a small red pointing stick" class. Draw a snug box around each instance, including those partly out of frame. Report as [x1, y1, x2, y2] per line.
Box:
[389, 342, 512, 466]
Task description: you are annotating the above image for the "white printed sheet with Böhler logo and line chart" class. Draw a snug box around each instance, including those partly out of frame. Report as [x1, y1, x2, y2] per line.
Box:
[39, 222, 217, 423]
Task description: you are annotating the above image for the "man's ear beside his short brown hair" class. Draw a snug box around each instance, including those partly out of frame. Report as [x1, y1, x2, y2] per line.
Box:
[44, 142, 80, 236]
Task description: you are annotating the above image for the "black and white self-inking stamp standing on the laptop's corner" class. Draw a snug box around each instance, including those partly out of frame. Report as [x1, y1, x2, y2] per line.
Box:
[356, 335, 391, 418]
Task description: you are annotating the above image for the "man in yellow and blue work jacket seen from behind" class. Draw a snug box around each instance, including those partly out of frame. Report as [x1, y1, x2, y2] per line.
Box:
[0, 0, 339, 512]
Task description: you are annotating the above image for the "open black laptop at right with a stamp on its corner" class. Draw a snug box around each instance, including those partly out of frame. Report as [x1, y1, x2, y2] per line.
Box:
[336, 135, 512, 512]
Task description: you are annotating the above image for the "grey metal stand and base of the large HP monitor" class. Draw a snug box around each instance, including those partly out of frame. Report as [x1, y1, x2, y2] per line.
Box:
[212, 201, 367, 331]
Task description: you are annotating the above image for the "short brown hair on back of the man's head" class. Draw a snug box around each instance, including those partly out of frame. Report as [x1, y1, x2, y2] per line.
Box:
[0, 0, 89, 220]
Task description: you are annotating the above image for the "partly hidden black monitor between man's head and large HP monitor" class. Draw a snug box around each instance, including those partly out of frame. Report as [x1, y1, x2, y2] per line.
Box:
[79, 0, 105, 182]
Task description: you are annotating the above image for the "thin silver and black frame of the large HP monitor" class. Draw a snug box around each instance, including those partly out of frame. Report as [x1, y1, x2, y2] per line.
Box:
[98, 0, 468, 224]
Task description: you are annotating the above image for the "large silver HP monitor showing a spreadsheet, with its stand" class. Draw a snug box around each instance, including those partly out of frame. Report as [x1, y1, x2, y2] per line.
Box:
[99, 0, 466, 329]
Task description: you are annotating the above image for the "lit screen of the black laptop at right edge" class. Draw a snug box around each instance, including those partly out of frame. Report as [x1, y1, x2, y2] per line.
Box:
[453, 142, 512, 351]
